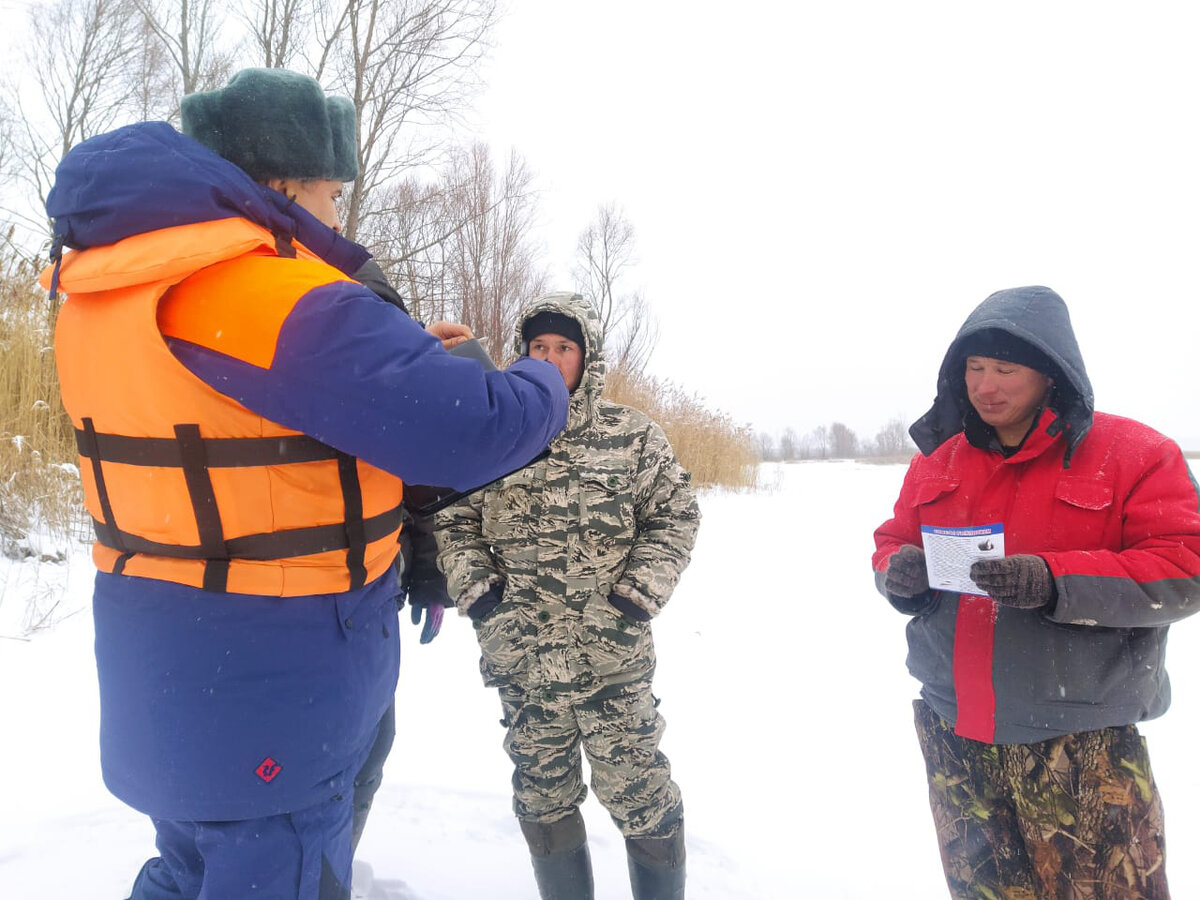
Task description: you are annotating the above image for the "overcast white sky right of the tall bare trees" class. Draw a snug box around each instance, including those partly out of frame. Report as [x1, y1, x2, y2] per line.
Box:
[468, 0, 1200, 449]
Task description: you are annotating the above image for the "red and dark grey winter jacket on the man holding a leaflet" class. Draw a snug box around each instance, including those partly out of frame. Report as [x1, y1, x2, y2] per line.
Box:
[872, 412, 1200, 744]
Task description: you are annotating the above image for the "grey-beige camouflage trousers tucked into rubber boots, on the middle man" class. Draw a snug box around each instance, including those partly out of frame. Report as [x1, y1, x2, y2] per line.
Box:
[499, 678, 683, 838]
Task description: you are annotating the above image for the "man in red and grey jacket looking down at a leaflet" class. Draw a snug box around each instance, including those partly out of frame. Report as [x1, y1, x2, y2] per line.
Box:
[874, 287, 1200, 899]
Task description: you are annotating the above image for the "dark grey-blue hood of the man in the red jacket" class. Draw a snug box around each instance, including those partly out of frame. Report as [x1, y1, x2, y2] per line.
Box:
[908, 286, 1096, 466]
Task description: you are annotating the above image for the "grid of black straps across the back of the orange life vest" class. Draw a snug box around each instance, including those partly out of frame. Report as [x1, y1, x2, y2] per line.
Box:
[76, 419, 401, 590]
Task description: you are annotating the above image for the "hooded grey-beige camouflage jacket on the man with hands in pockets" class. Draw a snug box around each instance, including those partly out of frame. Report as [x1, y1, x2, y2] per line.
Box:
[436, 294, 700, 680]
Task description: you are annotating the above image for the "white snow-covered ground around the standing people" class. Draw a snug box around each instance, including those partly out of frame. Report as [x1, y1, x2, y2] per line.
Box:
[0, 462, 1200, 900]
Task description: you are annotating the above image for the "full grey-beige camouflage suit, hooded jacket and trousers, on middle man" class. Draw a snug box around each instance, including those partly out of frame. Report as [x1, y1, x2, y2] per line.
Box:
[436, 294, 700, 838]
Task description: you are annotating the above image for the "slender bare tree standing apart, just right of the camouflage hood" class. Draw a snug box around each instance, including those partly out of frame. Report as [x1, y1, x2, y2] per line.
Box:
[575, 204, 658, 373]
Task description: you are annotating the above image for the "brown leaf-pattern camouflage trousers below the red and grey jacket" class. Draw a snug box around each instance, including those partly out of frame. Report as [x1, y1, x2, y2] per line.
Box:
[914, 700, 1170, 900]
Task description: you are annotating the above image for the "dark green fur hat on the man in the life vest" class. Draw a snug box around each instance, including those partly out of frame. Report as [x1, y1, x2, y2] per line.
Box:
[180, 68, 359, 181]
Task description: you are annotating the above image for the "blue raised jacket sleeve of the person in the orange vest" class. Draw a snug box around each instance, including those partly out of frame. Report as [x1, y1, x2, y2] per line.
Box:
[169, 282, 568, 490]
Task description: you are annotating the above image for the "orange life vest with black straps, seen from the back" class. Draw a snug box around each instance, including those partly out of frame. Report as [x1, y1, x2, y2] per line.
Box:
[51, 218, 403, 596]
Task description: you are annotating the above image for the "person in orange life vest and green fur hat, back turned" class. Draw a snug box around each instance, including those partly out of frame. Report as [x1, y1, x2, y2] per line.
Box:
[44, 70, 568, 900]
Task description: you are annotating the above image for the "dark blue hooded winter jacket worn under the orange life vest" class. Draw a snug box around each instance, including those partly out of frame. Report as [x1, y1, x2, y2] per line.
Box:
[47, 122, 568, 821]
